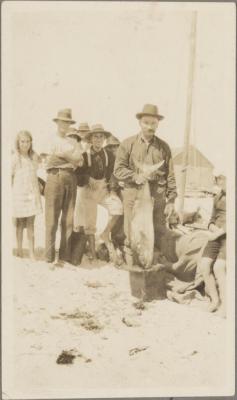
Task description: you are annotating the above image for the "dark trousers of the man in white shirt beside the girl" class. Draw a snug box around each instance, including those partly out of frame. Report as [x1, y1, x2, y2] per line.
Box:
[45, 168, 77, 262]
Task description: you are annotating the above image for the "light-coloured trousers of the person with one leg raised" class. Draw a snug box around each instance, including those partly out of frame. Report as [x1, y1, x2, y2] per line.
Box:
[80, 178, 123, 235]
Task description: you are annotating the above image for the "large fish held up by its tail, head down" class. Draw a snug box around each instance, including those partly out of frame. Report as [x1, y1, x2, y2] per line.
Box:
[131, 161, 164, 269]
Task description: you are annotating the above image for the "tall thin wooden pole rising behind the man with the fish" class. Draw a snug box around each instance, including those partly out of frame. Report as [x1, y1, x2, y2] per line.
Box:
[179, 11, 197, 223]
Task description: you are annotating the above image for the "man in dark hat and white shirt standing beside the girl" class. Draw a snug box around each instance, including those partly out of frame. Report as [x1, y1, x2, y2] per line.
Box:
[45, 109, 82, 263]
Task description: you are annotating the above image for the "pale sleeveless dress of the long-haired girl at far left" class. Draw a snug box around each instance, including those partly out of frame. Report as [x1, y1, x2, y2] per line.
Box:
[12, 154, 42, 218]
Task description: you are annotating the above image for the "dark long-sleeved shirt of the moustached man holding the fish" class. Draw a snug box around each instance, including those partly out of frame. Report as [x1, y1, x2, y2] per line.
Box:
[114, 133, 177, 202]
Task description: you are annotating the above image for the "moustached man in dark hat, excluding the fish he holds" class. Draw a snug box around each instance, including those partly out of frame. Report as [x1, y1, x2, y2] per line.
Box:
[114, 104, 177, 263]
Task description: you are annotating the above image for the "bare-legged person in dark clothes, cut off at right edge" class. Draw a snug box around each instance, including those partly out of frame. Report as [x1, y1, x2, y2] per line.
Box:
[199, 173, 226, 317]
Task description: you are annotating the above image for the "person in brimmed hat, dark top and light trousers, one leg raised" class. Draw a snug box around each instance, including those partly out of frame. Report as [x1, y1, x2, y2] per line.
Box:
[77, 124, 123, 260]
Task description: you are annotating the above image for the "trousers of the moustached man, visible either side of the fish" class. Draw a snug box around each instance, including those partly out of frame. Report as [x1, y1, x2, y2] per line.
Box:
[123, 188, 166, 247]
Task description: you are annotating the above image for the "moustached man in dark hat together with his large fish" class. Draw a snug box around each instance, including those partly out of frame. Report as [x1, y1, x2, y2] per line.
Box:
[114, 104, 177, 267]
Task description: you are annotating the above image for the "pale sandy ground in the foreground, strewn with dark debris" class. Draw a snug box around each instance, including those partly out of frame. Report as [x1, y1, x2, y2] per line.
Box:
[5, 202, 233, 398]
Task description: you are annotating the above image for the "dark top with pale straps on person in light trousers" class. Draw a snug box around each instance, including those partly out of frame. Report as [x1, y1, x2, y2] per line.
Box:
[76, 147, 115, 188]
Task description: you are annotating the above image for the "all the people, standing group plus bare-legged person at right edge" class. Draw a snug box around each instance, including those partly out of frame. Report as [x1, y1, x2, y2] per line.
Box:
[12, 104, 226, 318]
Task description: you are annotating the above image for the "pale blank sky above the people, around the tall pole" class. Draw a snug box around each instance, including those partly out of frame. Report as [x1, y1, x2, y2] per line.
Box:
[3, 1, 235, 169]
